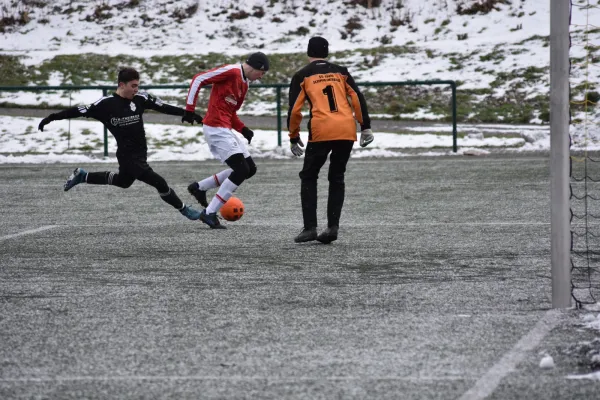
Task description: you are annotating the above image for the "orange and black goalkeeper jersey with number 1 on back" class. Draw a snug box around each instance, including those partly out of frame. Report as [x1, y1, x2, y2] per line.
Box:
[287, 60, 371, 142]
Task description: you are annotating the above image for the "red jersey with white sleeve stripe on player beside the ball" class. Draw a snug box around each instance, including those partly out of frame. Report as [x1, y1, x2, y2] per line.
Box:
[185, 64, 248, 132]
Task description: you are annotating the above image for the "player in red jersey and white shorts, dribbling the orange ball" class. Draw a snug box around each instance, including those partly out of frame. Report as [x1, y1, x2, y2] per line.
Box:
[182, 52, 269, 229]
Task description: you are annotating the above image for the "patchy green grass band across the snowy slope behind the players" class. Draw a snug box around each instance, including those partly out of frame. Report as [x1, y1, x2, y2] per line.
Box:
[0, 41, 556, 124]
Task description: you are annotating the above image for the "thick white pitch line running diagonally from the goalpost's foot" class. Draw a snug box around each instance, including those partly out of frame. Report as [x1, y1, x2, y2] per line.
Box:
[459, 310, 560, 400]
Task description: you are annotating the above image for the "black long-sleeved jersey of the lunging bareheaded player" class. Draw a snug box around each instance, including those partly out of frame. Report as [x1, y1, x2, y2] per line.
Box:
[53, 92, 184, 154]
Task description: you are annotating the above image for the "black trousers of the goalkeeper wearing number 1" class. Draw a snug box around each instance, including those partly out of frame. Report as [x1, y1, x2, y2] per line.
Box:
[300, 140, 354, 228]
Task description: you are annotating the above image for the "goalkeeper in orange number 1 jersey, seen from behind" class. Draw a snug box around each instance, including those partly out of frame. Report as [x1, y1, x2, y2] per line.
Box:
[288, 36, 373, 243]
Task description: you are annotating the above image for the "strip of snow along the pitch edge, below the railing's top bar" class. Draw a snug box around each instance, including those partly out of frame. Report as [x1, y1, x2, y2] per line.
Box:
[0, 116, 549, 163]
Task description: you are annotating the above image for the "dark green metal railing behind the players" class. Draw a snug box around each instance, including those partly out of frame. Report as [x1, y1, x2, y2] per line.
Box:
[0, 80, 458, 157]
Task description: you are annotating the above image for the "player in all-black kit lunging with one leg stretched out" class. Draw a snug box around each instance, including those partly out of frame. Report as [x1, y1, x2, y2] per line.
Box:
[38, 68, 202, 220]
